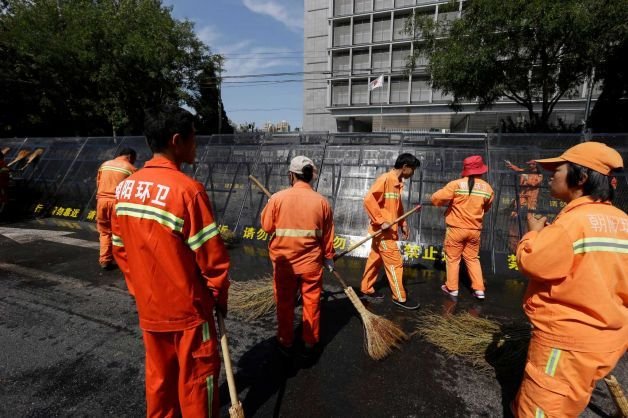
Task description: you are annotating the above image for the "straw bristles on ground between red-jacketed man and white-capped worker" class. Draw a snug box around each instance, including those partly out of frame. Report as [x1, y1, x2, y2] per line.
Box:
[229, 275, 275, 321]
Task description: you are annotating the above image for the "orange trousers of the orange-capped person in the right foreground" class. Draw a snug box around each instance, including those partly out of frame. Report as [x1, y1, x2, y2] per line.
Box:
[513, 337, 626, 418]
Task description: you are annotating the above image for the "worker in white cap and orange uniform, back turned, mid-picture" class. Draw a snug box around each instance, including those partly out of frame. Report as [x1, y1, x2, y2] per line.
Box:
[261, 156, 335, 357]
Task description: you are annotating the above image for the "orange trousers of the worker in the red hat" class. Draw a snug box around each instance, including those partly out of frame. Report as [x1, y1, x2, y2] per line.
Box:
[445, 226, 484, 291]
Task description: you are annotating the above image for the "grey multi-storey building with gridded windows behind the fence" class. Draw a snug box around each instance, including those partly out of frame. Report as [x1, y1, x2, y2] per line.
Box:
[303, 0, 597, 132]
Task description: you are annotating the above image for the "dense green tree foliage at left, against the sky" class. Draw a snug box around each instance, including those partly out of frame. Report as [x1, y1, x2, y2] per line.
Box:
[0, 0, 231, 136]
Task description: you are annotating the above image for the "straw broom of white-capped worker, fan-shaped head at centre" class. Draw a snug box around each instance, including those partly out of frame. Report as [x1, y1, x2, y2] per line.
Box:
[249, 176, 416, 360]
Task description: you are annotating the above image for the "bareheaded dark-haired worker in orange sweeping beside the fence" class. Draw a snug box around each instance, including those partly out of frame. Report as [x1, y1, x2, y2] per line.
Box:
[360, 153, 421, 310]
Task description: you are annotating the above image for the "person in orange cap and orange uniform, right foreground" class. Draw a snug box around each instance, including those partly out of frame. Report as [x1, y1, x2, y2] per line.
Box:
[514, 142, 628, 418]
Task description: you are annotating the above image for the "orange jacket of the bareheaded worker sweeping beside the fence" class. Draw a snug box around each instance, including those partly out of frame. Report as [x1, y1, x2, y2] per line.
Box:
[364, 170, 406, 240]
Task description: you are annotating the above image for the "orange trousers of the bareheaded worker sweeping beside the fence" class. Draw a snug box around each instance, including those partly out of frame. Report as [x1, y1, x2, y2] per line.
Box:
[360, 237, 406, 302]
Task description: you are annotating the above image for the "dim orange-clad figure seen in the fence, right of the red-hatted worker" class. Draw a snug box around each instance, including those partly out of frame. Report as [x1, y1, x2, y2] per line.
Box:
[505, 160, 543, 252]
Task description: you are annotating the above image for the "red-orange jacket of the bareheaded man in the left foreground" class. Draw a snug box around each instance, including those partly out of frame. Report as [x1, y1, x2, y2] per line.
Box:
[111, 157, 229, 331]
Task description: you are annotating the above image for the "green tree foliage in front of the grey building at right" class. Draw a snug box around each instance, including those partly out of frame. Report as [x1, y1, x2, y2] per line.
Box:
[405, 0, 628, 130]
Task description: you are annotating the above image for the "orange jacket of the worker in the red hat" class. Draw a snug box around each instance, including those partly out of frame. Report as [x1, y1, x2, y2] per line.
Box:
[432, 177, 495, 229]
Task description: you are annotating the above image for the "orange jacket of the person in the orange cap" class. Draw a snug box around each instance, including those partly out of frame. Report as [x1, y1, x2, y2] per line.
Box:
[517, 197, 628, 352]
